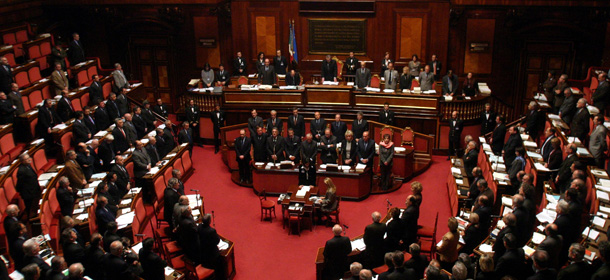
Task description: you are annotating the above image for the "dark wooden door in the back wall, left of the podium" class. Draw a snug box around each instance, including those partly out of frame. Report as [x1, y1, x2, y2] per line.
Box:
[129, 36, 176, 108]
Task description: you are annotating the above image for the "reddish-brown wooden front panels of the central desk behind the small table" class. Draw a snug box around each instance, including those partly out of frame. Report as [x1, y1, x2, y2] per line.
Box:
[252, 166, 372, 200]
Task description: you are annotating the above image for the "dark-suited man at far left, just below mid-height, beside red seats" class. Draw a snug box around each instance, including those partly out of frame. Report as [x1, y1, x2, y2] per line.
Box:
[15, 153, 41, 218]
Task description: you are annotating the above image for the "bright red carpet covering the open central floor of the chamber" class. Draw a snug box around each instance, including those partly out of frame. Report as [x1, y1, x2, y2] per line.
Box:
[186, 146, 449, 280]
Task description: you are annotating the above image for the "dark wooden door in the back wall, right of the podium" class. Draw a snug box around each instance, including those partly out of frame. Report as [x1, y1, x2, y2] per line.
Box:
[515, 41, 574, 110]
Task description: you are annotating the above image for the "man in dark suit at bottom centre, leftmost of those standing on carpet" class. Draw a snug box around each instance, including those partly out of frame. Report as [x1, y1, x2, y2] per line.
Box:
[322, 225, 352, 279]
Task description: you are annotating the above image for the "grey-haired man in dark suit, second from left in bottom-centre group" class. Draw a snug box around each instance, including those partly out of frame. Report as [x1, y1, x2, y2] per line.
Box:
[363, 212, 386, 267]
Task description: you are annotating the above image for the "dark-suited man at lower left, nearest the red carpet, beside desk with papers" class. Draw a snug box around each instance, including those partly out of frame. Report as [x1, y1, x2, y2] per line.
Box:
[197, 214, 226, 279]
